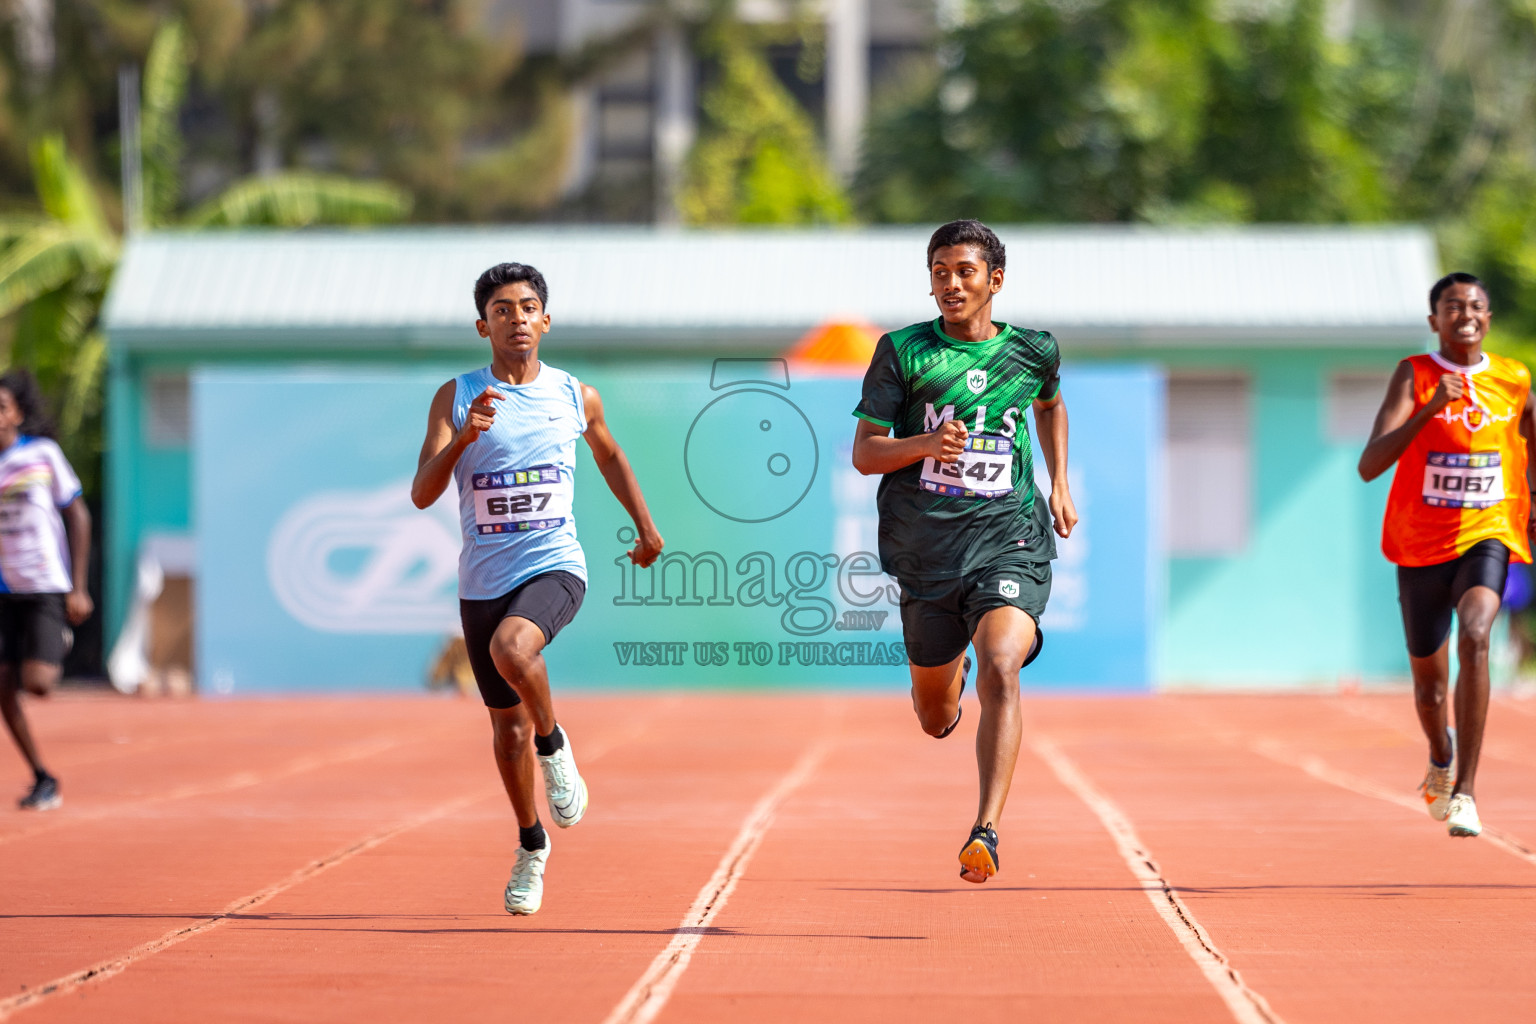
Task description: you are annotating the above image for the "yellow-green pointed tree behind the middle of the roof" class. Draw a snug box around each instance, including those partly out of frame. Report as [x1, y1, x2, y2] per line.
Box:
[679, 20, 849, 224]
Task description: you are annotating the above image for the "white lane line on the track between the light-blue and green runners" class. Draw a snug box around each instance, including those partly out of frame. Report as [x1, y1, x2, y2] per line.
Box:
[604, 740, 831, 1024]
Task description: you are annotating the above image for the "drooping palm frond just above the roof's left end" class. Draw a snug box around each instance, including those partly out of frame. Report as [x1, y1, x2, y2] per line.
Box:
[186, 172, 410, 227]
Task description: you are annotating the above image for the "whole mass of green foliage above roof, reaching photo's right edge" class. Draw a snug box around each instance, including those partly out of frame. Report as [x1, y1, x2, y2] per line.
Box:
[856, 0, 1536, 353]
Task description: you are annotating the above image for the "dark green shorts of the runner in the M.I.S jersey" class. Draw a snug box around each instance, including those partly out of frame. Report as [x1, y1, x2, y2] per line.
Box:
[897, 556, 1051, 668]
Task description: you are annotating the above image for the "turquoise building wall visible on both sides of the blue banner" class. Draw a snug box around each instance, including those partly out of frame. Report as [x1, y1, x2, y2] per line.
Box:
[104, 339, 1409, 688]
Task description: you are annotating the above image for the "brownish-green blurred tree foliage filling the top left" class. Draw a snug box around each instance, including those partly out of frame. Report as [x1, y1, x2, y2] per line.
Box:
[0, 0, 626, 223]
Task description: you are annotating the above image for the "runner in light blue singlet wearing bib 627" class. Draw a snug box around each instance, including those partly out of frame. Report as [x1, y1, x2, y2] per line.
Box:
[410, 263, 664, 915]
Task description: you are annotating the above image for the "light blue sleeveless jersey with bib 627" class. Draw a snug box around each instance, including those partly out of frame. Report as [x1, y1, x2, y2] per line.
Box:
[453, 362, 587, 600]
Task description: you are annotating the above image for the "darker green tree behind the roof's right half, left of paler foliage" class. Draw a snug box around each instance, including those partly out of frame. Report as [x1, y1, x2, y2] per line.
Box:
[859, 0, 1405, 223]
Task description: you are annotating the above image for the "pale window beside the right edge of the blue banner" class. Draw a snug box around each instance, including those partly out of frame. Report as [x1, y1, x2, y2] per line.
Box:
[1167, 375, 1253, 556]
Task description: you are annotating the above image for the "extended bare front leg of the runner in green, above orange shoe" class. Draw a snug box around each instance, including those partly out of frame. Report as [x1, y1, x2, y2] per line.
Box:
[972, 606, 1035, 824]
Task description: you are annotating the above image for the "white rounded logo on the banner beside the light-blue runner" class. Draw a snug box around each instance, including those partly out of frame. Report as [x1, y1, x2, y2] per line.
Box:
[267, 479, 461, 634]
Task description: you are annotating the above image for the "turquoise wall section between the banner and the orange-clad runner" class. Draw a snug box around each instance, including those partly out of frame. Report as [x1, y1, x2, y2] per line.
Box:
[1069, 347, 1410, 689]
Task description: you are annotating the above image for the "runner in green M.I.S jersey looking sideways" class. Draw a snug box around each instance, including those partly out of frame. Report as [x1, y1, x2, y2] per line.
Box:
[854, 221, 1077, 881]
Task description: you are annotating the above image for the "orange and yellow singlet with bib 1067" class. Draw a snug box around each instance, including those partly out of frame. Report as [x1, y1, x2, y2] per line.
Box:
[1381, 352, 1531, 567]
